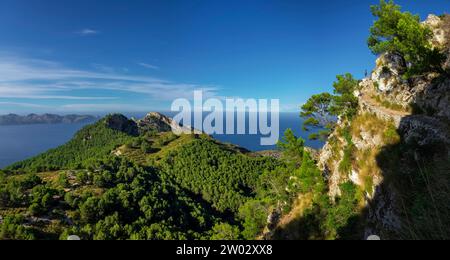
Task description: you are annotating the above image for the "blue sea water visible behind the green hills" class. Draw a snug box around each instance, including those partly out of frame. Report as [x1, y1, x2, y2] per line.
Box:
[0, 113, 323, 168]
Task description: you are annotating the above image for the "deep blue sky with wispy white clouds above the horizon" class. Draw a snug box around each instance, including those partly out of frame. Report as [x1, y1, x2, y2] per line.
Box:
[0, 0, 450, 114]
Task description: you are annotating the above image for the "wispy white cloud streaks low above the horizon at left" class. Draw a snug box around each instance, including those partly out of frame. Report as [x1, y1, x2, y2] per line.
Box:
[0, 56, 218, 110]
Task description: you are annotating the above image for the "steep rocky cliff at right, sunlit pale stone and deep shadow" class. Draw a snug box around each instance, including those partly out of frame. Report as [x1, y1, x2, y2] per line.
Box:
[318, 16, 450, 239]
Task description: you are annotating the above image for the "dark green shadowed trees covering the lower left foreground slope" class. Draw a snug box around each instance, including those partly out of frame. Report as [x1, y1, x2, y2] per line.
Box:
[0, 158, 236, 239]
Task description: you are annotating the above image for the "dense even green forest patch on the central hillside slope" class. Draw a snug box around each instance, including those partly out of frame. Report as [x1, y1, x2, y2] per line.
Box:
[161, 138, 276, 212]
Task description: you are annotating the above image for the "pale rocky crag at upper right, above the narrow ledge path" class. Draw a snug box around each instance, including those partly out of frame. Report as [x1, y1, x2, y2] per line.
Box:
[361, 15, 450, 120]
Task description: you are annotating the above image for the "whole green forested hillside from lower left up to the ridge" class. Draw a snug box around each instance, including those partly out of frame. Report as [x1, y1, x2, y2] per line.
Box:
[0, 115, 282, 239]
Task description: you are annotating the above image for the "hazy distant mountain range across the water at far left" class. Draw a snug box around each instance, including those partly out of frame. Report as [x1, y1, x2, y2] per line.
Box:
[0, 114, 98, 126]
